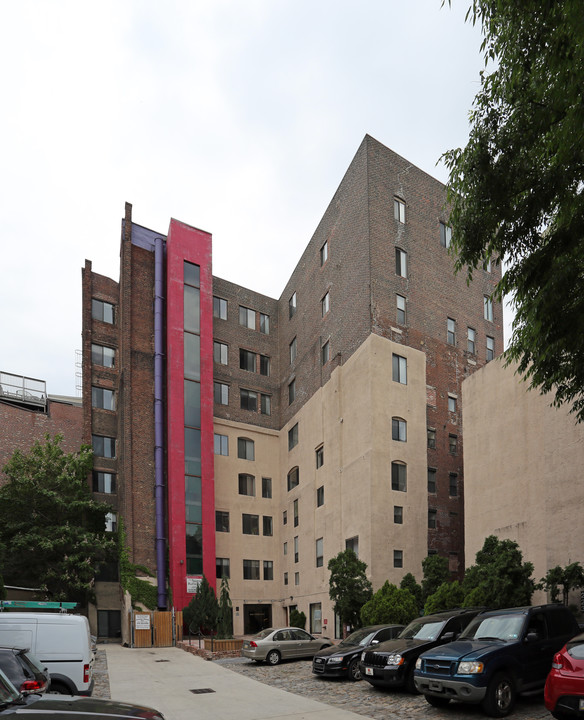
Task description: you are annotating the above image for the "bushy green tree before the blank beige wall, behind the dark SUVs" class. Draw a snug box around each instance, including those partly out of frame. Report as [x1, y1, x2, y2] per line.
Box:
[462, 535, 535, 610]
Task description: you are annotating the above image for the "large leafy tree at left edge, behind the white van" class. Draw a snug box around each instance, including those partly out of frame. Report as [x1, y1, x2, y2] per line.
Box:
[0, 435, 117, 604]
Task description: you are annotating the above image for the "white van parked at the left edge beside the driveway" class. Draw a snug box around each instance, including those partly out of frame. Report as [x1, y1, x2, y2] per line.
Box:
[0, 612, 94, 695]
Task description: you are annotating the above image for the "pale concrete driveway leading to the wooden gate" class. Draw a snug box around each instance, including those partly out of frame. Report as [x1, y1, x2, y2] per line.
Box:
[105, 645, 363, 720]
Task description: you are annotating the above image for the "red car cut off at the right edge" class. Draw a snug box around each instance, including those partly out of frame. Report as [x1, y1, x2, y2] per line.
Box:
[543, 633, 584, 720]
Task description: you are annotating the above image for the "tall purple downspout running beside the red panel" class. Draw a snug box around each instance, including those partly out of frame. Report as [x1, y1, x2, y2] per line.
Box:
[154, 238, 167, 608]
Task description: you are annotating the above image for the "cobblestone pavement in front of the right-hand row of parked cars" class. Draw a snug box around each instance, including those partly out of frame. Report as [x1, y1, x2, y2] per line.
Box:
[216, 658, 551, 720]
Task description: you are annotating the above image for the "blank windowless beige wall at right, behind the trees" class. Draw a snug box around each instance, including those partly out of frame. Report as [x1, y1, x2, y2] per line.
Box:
[462, 360, 584, 602]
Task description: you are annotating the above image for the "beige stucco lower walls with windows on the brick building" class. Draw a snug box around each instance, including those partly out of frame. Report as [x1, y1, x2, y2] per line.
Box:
[215, 335, 428, 636]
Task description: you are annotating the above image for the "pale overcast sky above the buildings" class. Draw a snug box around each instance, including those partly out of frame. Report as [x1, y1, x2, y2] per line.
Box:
[0, 0, 506, 395]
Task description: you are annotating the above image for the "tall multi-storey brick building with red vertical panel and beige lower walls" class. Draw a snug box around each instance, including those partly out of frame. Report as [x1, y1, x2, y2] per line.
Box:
[83, 136, 503, 636]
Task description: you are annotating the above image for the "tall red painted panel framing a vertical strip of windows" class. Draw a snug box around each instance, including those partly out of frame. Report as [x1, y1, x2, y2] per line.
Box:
[166, 219, 215, 610]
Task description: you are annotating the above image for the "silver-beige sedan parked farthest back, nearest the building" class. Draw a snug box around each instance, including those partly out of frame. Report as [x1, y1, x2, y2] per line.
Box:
[241, 628, 332, 665]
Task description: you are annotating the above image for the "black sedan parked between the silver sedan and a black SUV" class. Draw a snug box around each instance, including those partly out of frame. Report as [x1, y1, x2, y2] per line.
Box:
[312, 625, 404, 680]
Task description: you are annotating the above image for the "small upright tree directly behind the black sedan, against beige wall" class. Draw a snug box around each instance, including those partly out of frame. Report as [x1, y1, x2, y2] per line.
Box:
[327, 548, 372, 628]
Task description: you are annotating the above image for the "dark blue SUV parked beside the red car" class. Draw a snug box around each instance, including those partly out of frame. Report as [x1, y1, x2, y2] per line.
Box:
[414, 605, 578, 717]
